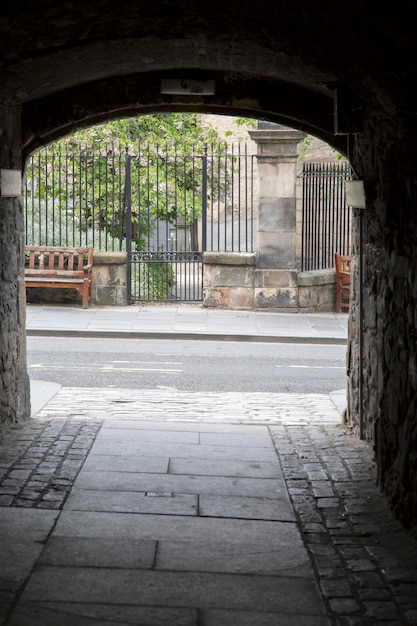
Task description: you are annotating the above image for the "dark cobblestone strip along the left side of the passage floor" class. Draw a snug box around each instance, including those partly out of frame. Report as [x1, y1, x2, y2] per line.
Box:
[0, 418, 101, 509]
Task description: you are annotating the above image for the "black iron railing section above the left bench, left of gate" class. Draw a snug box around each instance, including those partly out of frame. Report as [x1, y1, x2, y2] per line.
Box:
[24, 143, 125, 251]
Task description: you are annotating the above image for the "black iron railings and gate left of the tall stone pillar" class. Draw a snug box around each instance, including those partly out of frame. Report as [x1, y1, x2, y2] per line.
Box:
[24, 142, 256, 300]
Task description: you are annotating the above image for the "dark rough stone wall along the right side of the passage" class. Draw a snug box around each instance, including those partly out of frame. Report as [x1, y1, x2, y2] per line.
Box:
[348, 115, 417, 527]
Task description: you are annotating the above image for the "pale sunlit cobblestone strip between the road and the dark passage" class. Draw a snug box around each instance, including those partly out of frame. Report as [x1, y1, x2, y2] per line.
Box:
[34, 387, 340, 425]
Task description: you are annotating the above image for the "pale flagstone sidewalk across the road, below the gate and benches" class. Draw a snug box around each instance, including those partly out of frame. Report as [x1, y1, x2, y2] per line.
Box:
[26, 303, 348, 344]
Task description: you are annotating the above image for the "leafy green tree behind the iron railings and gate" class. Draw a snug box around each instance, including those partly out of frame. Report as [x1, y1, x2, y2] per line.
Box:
[27, 113, 227, 248]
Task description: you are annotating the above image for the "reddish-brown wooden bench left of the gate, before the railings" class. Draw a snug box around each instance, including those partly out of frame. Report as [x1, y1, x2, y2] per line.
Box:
[25, 246, 93, 309]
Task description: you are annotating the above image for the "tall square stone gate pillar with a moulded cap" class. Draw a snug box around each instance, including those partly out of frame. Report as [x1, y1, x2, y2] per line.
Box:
[250, 123, 304, 309]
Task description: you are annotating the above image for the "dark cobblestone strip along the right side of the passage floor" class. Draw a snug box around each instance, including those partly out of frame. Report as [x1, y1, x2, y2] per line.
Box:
[270, 426, 417, 626]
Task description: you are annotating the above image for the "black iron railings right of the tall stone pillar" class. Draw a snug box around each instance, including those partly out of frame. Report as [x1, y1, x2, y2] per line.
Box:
[301, 162, 352, 271]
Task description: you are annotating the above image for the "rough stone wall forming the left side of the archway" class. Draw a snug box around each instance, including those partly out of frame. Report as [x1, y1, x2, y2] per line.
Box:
[0, 105, 30, 433]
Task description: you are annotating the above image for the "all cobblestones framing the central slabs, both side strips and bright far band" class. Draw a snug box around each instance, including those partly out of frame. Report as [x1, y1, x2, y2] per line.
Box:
[0, 388, 417, 626]
